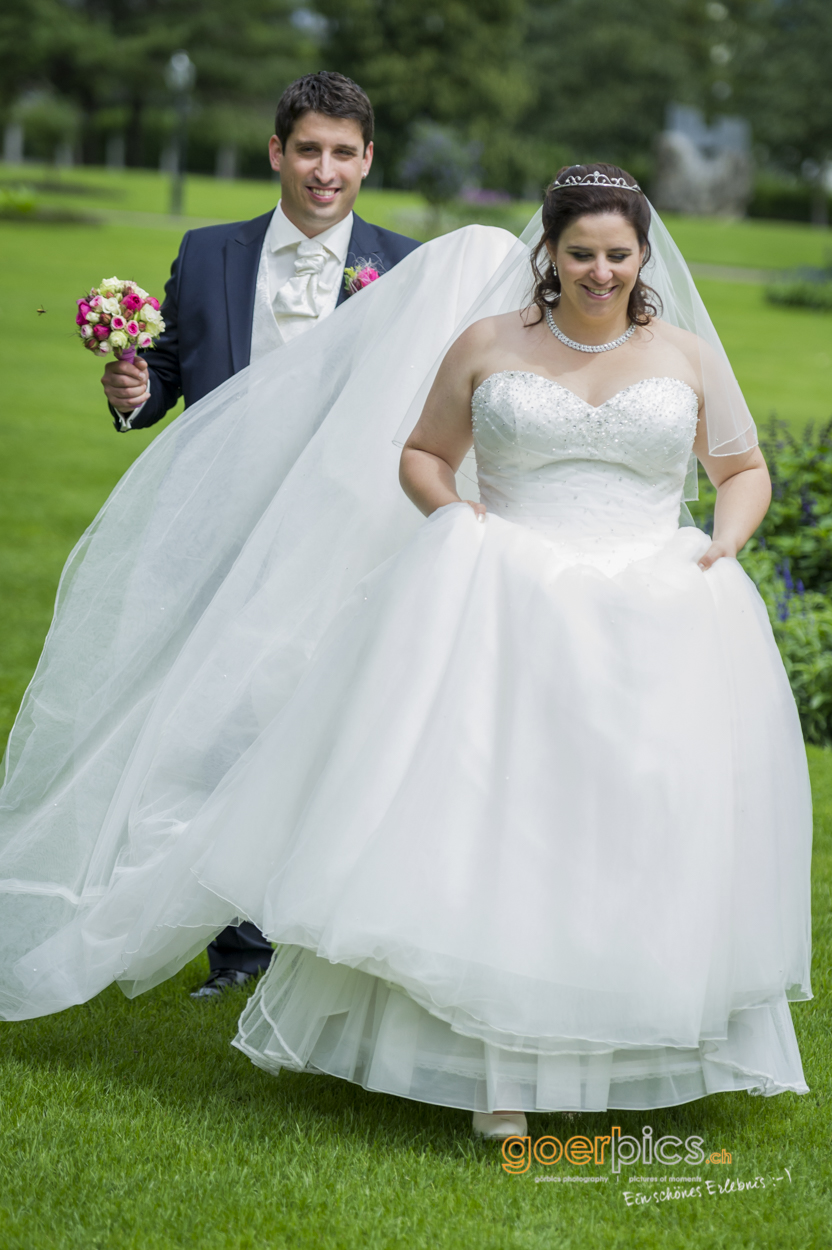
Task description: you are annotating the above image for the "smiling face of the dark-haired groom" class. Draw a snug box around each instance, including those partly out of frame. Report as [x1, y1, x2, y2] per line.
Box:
[269, 113, 372, 239]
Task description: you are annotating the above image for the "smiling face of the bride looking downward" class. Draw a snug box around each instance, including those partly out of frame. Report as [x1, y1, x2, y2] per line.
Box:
[546, 213, 645, 320]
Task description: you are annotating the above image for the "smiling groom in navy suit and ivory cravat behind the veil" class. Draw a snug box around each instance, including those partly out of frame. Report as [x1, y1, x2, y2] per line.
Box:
[101, 73, 418, 998]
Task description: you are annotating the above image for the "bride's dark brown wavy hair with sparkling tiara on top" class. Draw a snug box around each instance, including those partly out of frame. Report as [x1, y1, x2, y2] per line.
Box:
[531, 164, 661, 325]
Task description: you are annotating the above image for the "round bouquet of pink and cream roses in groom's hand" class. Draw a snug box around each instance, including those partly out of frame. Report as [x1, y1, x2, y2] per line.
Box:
[75, 278, 165, 363]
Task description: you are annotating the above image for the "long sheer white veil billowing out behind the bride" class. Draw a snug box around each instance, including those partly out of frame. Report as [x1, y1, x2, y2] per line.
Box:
[0, 207, 753, 1019]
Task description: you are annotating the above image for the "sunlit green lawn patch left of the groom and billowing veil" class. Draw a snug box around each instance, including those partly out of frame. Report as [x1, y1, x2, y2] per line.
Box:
[0, 225, 173, 741]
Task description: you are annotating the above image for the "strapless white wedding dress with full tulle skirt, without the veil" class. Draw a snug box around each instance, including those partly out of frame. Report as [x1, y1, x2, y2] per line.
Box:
[195, 373, 811, 1111]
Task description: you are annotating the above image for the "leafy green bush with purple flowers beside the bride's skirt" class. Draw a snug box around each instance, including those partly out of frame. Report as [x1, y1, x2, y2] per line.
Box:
[691, 421, 832, 745]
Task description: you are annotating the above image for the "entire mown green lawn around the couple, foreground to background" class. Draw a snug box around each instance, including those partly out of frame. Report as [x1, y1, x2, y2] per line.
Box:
[0, 171, 832, 1250]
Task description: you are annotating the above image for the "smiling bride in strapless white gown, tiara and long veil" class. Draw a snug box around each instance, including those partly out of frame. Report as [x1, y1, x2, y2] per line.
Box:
[0, 165, 811, 1136]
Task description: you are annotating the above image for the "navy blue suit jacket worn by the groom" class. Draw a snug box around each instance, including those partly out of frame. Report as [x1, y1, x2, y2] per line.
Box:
[110, 213, 418, 430]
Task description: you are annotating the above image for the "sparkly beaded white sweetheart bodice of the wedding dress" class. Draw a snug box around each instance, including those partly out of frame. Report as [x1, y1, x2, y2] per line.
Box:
[471, 370, 698, 562]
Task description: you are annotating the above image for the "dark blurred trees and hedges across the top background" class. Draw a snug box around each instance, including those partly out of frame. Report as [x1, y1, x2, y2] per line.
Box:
[0, 0, 832, 220]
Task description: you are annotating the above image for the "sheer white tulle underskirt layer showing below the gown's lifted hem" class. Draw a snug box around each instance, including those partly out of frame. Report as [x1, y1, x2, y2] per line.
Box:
[234, 946, 806, 1111]
